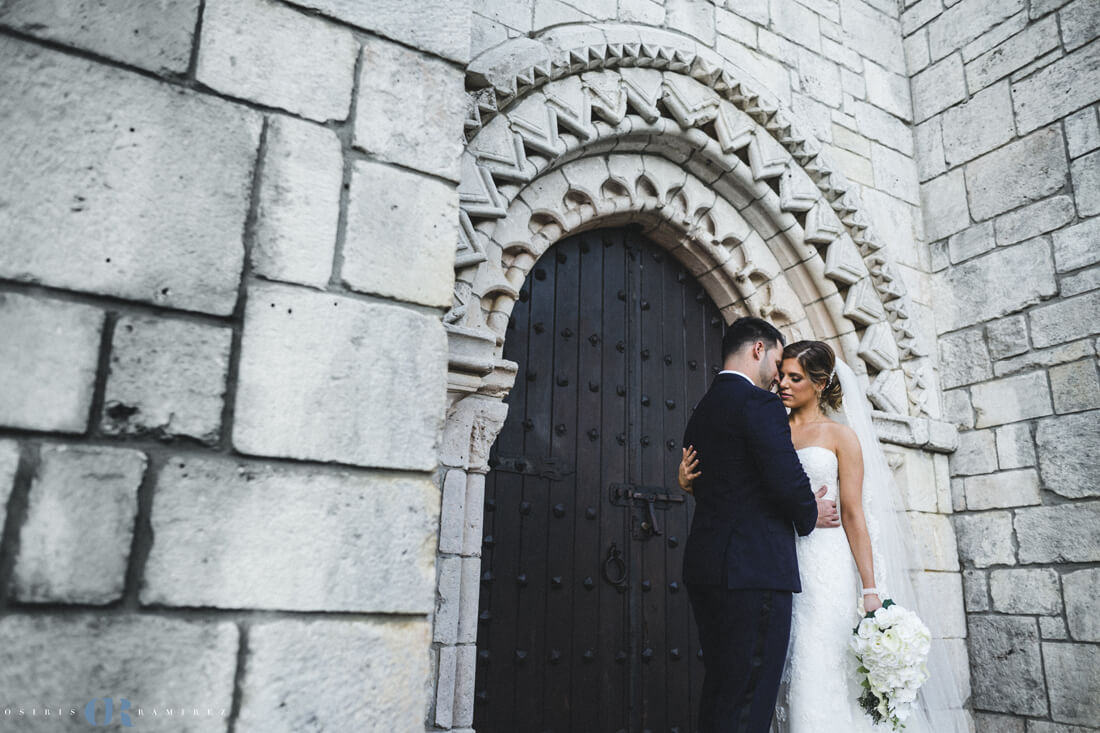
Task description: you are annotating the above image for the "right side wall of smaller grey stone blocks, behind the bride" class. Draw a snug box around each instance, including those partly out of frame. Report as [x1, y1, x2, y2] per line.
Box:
[901, 0, 1100, 733]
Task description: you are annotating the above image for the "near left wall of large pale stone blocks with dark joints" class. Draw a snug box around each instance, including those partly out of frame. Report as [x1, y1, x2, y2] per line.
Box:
[0, 0, 470, 732]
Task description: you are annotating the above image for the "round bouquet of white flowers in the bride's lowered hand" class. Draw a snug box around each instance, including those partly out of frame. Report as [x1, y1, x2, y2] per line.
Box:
[851, 600, 932, 731]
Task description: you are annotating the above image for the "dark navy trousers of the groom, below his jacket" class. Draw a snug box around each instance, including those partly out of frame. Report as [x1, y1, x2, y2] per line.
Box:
[688, 584, 791, 733]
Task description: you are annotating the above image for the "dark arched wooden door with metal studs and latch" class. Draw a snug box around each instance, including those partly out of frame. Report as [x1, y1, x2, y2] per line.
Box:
[474, 229, 723, 733]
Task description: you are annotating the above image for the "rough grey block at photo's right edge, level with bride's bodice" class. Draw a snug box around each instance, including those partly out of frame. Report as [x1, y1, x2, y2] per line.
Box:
[1035, 407, 1100, 499]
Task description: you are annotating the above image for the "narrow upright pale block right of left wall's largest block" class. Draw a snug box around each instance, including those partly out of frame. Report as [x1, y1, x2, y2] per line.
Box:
[251, 116, 343, 287]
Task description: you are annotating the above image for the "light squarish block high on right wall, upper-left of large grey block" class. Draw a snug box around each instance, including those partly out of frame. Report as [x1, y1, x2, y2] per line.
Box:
[943, 81, 1016, 167]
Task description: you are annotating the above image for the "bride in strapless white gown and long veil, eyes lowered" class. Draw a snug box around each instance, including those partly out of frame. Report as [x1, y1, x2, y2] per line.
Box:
[680, 341, 968, 733]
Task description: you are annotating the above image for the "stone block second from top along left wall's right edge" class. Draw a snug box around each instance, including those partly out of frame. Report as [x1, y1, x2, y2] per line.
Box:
[355, 40, 466, 182]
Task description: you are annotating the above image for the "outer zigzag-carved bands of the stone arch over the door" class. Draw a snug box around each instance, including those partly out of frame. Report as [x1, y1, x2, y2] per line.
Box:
[459, 31, 928, 414]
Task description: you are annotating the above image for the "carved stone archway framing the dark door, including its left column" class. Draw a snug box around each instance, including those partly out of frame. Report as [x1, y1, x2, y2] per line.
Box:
[430, 26, 954, 730]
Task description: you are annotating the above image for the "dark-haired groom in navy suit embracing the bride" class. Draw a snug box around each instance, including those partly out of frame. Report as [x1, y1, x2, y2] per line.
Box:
[683, 318, 839, 733]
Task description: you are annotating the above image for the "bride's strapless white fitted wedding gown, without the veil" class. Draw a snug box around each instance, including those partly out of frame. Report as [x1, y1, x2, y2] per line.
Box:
[772, 446, 889, 733]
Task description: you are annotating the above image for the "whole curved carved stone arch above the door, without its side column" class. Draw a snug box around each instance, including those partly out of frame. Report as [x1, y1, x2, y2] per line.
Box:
[448, 25, 931, 413]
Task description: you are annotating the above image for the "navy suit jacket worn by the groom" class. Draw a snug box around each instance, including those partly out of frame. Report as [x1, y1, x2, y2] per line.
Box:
[683, 373, 817, 592]
